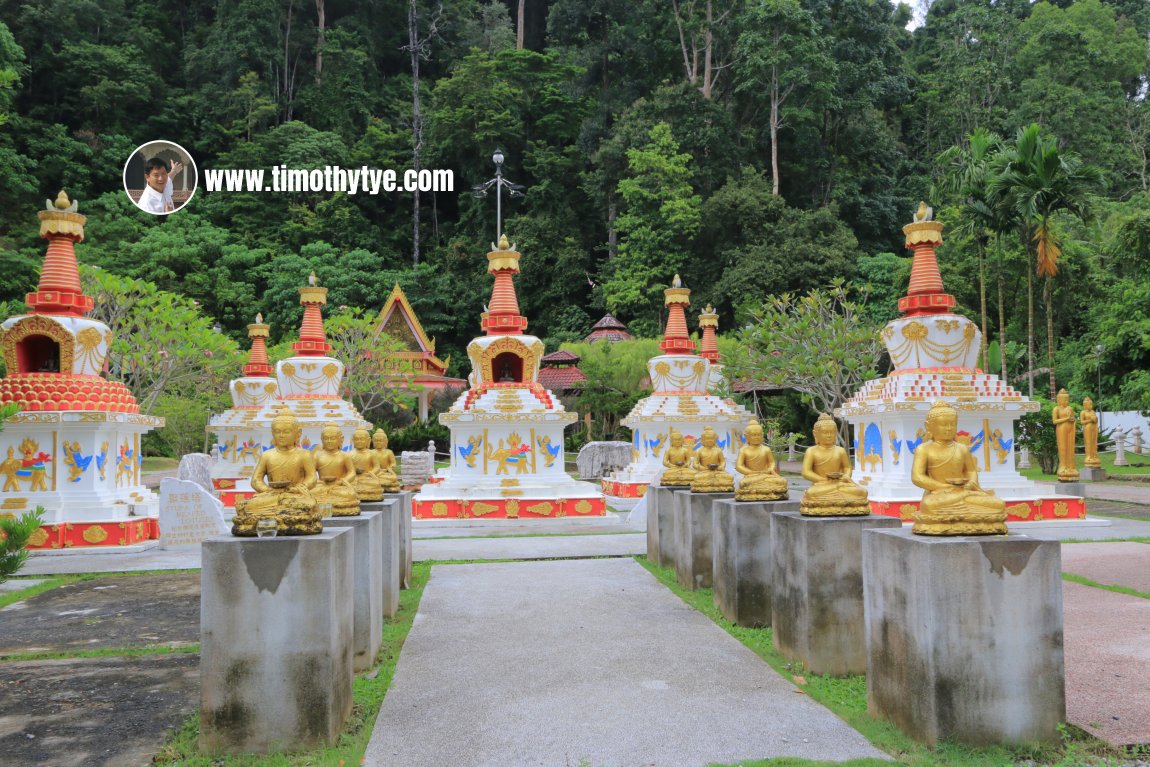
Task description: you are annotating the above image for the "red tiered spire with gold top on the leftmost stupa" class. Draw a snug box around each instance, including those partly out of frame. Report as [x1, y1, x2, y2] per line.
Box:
[24, 191, 94, 317]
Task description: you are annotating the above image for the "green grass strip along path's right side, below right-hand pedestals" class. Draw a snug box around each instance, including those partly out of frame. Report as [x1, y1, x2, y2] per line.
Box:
[635, 557, 1124, 767]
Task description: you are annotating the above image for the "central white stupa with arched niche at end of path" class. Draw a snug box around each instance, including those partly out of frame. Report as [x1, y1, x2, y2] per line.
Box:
[412, 236, 606, 520]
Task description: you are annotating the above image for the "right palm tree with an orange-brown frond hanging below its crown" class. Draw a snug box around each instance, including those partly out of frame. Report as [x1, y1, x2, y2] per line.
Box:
[989, 123, 1102, 399]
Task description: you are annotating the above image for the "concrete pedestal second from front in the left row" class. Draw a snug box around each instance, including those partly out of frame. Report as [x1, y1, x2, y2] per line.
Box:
[323, 512, 383, 672]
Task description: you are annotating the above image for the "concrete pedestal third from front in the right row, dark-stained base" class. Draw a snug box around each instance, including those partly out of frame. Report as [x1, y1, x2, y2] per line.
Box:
[712, 499, 798, 627]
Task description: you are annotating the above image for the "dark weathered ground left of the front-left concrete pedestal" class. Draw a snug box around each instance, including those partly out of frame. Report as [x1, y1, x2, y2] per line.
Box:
[0, 572, 200, 767]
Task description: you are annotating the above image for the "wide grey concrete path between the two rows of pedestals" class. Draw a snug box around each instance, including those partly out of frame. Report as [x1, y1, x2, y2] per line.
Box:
[363, 558, 887, 767]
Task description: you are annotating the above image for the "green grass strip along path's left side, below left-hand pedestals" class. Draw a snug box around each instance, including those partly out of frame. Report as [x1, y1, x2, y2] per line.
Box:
[153, 562, 431, 767]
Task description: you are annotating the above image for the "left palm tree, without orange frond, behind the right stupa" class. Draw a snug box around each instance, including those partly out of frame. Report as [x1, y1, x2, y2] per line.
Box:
[930, 128, 1005, 374]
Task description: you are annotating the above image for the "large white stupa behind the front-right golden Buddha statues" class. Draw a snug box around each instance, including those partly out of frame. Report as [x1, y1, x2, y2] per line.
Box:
[836, 204, 1086, 522]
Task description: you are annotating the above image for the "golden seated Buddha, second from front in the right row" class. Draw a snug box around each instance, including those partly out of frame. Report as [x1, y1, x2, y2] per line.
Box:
[799, 413, 871, 516]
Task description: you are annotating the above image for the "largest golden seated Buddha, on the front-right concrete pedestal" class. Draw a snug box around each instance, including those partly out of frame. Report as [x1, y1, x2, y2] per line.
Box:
[911, 402, 1006, 536]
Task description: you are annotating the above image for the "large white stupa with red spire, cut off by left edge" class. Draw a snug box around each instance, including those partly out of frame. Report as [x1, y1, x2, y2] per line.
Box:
[0, 192, 163, 550]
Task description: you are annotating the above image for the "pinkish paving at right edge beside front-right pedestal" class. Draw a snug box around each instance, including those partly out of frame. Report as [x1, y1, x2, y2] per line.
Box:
[1063, 581, 1150, 745]
